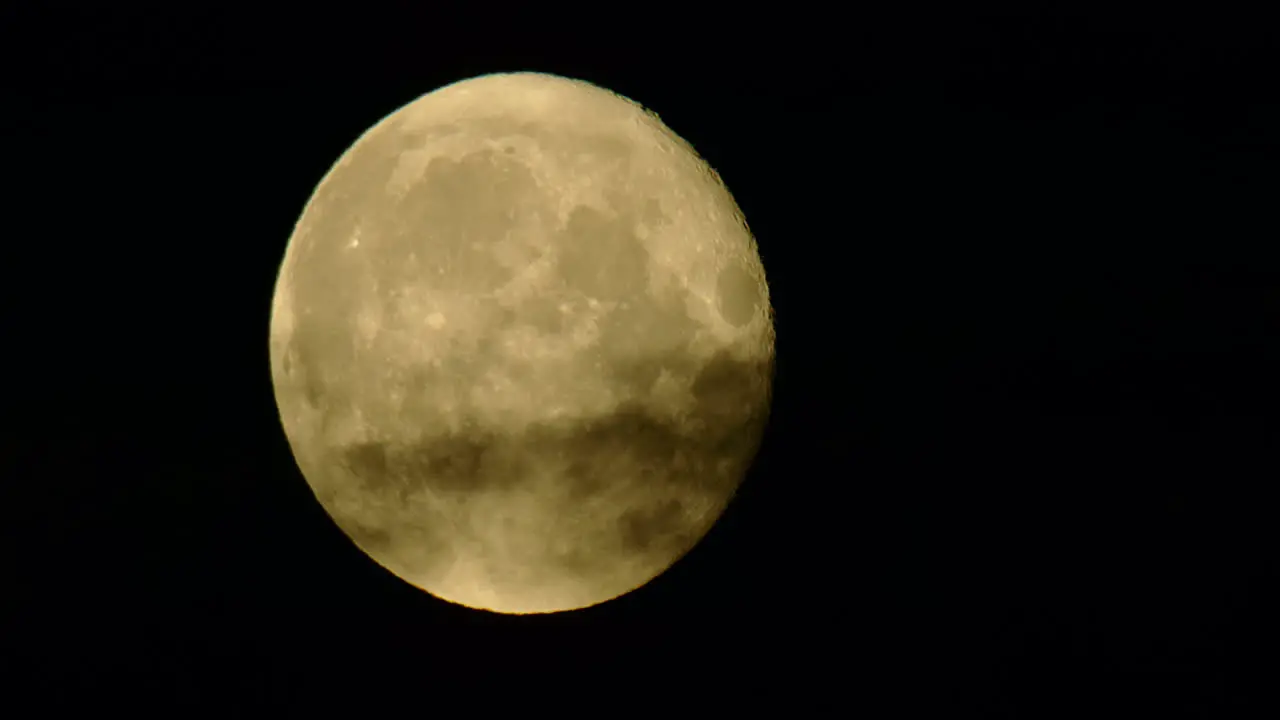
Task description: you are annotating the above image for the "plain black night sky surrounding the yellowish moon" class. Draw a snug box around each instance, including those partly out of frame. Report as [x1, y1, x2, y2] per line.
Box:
[0, 3, 1280, 717]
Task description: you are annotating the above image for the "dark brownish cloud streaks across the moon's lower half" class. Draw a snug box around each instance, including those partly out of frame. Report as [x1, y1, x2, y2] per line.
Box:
[329, 354, 769, 582]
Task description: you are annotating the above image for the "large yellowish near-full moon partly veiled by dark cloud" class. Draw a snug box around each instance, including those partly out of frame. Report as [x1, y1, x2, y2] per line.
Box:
[270, 73, 774, 614]
